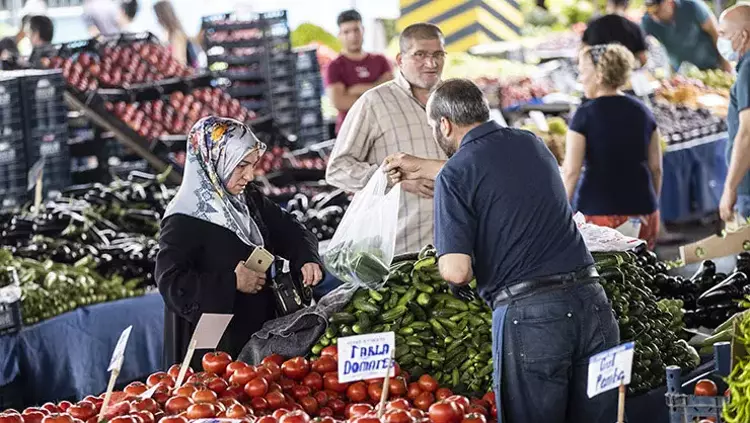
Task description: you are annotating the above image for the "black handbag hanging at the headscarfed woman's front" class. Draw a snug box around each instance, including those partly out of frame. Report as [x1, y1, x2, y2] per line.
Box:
[270, 257, 312, 317]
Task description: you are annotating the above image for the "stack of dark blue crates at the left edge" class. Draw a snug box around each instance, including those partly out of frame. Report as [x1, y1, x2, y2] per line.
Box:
[0, 70, 70, 208]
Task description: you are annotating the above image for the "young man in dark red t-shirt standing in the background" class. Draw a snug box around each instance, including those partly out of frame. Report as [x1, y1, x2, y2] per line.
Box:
[326, 10, 393, 134]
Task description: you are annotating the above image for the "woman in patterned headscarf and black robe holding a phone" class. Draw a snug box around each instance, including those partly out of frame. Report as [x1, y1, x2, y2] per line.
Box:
[156, 117, 323, 369]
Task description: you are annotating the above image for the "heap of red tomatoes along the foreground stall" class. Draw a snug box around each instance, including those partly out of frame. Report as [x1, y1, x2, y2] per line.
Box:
[0, 352, 506, 423]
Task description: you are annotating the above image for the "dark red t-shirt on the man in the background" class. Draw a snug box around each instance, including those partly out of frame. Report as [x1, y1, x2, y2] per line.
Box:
[326, 54, 391, 134]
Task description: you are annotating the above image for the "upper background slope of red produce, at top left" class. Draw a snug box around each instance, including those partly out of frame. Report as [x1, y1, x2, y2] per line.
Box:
[39, 41, 194, 91]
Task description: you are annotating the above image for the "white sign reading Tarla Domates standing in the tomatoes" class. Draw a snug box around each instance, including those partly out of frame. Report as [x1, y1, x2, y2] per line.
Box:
[338, 332, 396, 383]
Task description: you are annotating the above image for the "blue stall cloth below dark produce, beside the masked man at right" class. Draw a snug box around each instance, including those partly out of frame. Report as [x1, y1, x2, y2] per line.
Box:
[660, 133, 728, 222]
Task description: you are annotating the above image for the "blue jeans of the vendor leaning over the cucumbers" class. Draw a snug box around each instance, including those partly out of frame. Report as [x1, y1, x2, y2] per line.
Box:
[492, 283, 620, 423]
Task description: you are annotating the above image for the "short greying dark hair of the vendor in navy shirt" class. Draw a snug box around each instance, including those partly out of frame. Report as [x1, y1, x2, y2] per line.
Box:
[427, 78, 490, 126]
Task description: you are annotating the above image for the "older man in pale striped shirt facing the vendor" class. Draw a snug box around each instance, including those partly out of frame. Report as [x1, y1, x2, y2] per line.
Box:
[326, 23, 447, 254]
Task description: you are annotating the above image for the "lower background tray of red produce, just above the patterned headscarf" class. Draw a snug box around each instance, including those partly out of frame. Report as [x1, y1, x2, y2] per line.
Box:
[105, 87, 255, 140]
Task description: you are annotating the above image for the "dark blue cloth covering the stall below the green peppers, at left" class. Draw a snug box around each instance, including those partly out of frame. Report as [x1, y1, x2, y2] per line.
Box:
[0, 294, 164, 409]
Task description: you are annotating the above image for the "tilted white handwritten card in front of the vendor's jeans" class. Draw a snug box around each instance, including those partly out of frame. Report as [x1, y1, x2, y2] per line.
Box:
[586, 342, 635, 398]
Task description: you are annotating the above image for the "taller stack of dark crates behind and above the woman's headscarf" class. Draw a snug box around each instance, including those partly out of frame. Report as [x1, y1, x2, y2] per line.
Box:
[203, 11, 298, 134]
